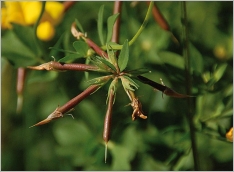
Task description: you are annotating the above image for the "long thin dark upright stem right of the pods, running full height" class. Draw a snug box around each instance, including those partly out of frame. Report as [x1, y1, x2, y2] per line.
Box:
[182, 1, 199, 171]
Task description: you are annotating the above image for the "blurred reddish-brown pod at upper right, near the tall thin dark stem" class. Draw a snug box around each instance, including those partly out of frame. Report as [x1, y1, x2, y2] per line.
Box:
[146, 1, 170, 31]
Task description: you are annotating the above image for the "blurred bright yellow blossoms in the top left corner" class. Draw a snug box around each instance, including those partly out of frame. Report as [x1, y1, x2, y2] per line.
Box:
[1, 1, 64, 41]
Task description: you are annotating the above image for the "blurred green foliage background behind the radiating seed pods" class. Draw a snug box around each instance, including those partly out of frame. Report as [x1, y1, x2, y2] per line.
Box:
[1, 1, 233, 171]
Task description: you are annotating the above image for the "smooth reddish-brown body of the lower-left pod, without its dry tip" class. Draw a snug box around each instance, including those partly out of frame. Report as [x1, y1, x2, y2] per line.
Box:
[57, 85, 100, 114]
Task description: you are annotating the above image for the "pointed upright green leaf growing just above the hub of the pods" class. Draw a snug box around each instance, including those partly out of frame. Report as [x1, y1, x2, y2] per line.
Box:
[118, 39, 129, 72]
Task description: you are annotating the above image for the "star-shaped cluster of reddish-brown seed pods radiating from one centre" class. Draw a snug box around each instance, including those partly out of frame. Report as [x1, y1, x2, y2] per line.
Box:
[16, 1, 201, 161]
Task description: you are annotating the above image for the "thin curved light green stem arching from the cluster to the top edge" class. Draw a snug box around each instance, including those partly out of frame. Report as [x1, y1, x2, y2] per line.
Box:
[102, 1, 154, 50]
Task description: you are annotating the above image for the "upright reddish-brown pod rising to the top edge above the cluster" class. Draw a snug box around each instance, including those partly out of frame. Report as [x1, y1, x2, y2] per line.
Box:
[111, 1, 122, 43]
